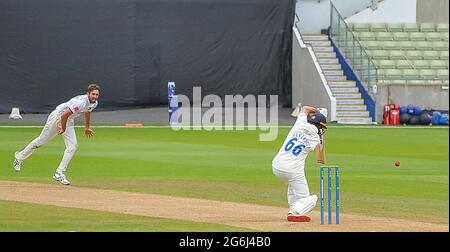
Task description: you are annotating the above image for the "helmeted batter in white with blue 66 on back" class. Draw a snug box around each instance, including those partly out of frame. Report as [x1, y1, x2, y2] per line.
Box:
[272, 106, 326, 222]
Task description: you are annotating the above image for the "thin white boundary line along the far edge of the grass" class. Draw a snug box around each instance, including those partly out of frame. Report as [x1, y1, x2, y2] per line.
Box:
[0, 125, 449, 131]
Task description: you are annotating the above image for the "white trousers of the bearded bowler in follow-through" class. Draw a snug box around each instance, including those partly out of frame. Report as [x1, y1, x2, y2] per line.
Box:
[16, 112, 78, 173]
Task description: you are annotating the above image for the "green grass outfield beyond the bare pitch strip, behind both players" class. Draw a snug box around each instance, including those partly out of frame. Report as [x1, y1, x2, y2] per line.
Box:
[0, 127, 449, 231]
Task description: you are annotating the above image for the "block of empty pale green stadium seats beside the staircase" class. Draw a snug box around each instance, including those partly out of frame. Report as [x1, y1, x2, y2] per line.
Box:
[344, 23, 449, 85]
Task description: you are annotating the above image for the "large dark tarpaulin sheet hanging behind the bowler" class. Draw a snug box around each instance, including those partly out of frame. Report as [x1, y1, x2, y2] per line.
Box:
[0, 0, 295, 113]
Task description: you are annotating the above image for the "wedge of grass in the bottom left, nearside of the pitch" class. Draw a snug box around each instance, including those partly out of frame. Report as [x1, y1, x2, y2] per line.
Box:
[0, 200, 251, 232]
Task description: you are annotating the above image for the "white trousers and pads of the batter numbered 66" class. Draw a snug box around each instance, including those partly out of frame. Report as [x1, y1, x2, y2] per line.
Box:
[272, 167, 317, 215]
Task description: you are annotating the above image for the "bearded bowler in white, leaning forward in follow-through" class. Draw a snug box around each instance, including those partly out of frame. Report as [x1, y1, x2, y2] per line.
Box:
[13, 84, 100, 185]
